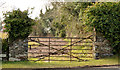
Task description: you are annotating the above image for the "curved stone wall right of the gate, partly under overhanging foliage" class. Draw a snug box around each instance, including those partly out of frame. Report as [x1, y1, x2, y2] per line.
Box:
[95, 33, 113, 58]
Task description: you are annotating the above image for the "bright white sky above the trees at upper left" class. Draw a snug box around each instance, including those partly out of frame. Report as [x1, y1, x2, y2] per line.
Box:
[0, 0, 51, 20]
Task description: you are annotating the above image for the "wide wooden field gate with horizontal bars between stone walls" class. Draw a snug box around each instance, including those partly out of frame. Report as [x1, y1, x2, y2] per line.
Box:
[28, 35, 94, 62]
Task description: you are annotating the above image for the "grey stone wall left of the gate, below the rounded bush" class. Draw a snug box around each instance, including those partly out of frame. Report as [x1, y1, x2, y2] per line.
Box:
[9, 39, 28, 61]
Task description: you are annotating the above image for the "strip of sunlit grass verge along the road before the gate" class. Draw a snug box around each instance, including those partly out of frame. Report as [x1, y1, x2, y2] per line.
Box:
[2, 56, 118, 68]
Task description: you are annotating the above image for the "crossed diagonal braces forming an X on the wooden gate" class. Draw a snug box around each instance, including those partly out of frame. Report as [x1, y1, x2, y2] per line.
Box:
[30, 35, 92, 61]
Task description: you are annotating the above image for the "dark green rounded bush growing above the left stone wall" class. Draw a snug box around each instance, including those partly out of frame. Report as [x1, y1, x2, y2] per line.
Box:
[4, 9, 35, 41]
